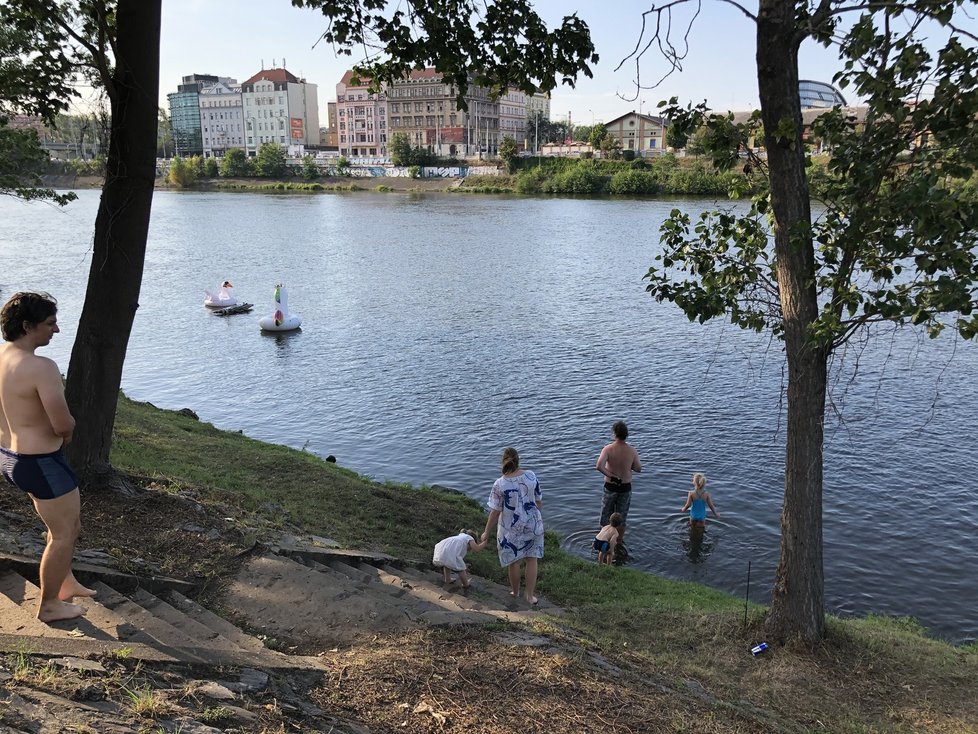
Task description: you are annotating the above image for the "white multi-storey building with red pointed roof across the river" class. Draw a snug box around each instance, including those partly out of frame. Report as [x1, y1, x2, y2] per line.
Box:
[241, 68, 319, 156]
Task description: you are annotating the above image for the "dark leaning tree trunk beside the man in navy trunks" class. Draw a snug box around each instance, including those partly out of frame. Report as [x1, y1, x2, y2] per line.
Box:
[66, 0, 161, 484]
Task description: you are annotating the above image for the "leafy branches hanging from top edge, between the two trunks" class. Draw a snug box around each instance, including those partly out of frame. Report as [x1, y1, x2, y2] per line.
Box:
[292, 0, 598, 109]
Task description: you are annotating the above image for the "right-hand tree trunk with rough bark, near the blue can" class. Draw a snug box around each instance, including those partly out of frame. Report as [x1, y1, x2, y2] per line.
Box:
[757, 0, 828, 645]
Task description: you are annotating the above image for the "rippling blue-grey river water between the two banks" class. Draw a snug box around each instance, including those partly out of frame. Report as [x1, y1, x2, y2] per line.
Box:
[0, 191, 978, 642]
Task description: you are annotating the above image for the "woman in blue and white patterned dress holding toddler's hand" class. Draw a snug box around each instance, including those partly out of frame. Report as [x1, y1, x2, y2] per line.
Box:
[482, 448, 543, 604]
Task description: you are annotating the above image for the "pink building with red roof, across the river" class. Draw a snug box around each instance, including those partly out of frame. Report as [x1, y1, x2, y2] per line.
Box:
[330, 71, 387, 158]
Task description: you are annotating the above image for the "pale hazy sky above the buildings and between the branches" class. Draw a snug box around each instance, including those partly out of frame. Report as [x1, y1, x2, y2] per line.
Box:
[154, 0, 960, 126]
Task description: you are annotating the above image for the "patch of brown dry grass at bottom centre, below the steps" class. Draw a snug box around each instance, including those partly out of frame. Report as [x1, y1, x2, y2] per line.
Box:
[313, 629, 769, 734]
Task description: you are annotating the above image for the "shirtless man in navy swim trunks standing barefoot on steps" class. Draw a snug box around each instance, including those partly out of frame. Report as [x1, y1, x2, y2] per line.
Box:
[0, 293, 95, 622]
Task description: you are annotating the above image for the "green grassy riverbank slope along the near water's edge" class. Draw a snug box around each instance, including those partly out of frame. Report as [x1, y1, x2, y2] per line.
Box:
[112, 398, 978, 732]
